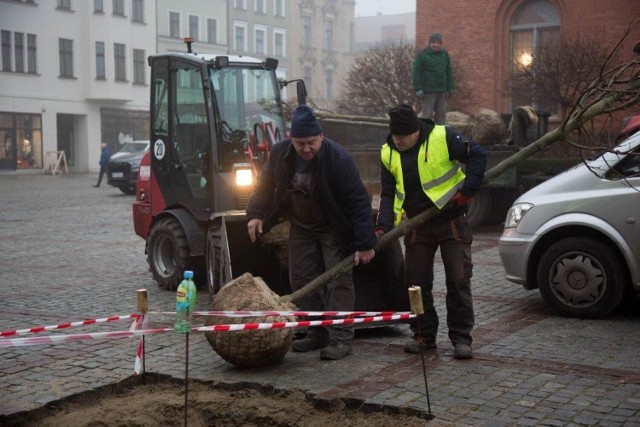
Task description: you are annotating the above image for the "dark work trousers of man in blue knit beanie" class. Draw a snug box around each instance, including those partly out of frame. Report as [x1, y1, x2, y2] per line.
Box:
[289, 224, 355, 341]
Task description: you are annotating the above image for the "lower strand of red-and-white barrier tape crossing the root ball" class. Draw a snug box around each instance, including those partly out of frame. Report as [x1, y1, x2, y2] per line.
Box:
[0, 313, 416, 348]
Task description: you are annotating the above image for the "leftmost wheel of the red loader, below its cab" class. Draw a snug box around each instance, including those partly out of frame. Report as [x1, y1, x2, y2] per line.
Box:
[147, 218, 190, 291]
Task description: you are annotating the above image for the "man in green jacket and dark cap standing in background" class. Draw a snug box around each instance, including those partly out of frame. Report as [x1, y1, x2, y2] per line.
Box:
[413, 33, 455, 125]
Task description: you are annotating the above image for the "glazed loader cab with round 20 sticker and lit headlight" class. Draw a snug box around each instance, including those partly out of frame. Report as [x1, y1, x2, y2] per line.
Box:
[149, 53, 285, 221]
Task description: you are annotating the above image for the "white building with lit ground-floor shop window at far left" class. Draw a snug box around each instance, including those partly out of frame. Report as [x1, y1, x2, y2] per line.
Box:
[0, 0, 155, 171]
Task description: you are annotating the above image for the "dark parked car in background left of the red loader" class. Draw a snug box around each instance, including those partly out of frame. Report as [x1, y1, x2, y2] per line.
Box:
[107, 141, 149, 194]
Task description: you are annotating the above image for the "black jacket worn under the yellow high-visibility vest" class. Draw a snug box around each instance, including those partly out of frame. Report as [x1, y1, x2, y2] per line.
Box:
[376, 119, 487, 231]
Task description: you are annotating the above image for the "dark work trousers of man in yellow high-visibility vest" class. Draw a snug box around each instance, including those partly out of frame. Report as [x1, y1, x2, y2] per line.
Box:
[405, 215, 475, 345]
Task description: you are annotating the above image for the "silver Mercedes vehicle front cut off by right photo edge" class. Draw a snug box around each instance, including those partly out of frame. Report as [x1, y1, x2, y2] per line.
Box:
[499, 117, 640, 318]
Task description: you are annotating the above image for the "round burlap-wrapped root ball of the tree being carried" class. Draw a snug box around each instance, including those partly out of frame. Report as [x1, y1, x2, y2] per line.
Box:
[205, 273, 296, 368]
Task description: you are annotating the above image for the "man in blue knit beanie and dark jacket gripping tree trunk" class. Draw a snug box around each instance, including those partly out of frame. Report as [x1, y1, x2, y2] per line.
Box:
[247, 105, 377, 360]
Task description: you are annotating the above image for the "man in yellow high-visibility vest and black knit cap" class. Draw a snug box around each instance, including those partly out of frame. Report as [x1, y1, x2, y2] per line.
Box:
[376, 105, 487, 359]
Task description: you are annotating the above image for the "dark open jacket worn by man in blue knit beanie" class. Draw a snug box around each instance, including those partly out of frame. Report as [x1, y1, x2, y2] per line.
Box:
[247, 138, 376, 250]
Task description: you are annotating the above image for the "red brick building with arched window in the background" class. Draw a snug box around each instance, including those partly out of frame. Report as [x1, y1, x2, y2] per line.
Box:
[416, 0, 640, 121]
